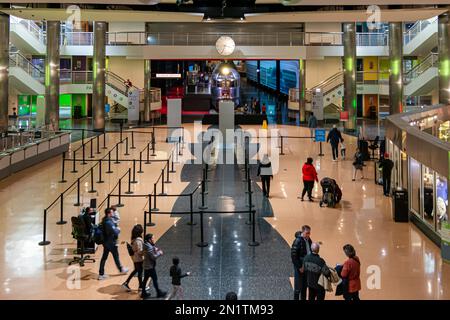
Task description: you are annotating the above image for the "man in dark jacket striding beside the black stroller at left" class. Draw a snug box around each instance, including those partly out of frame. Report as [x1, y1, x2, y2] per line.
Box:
[98, 208, 128, 280]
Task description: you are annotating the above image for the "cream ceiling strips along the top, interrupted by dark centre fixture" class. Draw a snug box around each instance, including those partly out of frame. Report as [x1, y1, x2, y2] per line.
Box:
[0, 7, 445, 23]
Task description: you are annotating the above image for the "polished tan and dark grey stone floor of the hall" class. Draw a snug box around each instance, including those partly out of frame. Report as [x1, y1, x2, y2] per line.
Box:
[0, 124, 450, 299]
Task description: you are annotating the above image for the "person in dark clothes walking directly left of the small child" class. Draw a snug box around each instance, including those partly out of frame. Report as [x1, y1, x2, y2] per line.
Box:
[141, 233, 166, 299]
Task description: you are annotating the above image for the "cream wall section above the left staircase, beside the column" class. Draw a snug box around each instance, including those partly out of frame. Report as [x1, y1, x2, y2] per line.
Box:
[109, 57, 144, 89]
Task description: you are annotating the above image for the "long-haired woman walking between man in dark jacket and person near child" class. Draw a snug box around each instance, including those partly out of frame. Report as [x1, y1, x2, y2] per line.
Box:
[122, 224, 144, 292]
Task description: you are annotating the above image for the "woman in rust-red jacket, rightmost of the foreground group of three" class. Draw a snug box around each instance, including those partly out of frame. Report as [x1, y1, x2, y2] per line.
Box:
[341, 244, 361, 300]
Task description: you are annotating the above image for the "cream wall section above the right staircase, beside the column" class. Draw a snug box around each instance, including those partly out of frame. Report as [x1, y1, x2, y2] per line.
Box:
[306, 57, 342, 89]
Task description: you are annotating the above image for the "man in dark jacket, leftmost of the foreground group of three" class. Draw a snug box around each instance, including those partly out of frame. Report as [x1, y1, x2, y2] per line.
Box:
[291, 225, 312, 300]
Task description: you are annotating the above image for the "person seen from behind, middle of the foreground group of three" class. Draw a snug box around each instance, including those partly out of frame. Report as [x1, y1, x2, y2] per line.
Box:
[302, 242, 331, 300]
